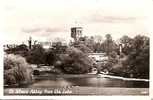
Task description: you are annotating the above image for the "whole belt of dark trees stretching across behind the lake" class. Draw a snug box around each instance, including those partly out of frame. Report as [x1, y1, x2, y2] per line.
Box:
[5, 34, 150, 78]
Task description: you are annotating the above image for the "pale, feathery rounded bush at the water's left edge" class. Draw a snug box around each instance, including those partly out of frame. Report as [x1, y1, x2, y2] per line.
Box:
[4, 54, 31, 85]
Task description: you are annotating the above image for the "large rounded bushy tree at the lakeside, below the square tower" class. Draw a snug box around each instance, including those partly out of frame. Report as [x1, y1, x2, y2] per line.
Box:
[56, 47, 93, 74]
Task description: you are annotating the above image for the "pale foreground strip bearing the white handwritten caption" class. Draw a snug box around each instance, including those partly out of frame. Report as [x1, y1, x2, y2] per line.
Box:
[4, 86, 149, 96]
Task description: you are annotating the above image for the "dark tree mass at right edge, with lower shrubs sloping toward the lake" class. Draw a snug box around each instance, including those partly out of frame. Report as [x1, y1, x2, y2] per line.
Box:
[113, 35, 149, 78]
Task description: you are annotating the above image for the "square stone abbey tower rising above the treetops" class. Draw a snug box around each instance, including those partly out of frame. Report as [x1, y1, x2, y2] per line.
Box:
[71, 27, 83, 42]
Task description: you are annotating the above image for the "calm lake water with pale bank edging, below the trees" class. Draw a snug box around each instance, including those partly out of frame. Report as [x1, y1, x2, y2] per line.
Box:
[4, 74, 149, 88]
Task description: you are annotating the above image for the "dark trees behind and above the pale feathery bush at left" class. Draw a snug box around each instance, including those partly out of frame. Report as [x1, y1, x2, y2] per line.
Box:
[6, 44, 58, 65]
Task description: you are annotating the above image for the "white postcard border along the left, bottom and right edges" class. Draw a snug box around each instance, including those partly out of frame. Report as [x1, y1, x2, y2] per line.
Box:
[0, 0, 153, 100]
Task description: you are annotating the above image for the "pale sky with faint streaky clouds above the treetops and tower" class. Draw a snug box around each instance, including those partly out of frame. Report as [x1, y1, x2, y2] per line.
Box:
[0, 0, 153, 43]
